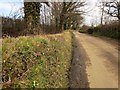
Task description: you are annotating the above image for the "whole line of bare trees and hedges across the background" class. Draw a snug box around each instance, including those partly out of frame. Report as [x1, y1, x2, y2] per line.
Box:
[2, 0, 120, 38]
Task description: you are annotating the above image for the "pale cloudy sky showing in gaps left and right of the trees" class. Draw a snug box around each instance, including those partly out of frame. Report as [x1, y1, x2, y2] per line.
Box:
[0, 0, 100, 25]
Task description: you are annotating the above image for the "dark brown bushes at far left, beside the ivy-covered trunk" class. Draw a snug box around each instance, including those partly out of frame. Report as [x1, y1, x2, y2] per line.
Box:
[2, 17, 24, 37]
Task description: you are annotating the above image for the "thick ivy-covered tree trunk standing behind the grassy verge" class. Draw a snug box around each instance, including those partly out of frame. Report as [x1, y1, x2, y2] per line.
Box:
[24, 2, 40, 34]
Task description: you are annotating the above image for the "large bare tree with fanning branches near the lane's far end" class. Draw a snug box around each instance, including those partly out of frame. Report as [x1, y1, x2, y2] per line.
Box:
[52, 0, 85, 31]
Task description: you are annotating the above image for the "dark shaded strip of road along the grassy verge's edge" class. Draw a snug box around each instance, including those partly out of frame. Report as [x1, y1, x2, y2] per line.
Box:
[70, 32, 89, 88]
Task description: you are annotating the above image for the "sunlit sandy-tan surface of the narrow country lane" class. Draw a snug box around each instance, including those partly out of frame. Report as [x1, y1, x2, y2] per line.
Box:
[71, 32, 118, 88]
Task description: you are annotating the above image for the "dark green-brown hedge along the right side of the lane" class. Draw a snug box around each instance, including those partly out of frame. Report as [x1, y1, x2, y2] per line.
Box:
[93, 21, 120, 39]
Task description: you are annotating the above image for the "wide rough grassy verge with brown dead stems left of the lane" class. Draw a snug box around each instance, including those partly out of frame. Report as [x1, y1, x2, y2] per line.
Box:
[2, 32, 72, 89]
